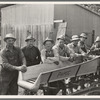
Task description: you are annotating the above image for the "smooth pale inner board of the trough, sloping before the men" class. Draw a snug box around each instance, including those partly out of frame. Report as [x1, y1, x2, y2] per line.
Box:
[22, 62, 72, 80]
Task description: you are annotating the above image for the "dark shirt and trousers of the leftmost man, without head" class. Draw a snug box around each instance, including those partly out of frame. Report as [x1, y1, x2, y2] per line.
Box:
[0, 46, 26, 95]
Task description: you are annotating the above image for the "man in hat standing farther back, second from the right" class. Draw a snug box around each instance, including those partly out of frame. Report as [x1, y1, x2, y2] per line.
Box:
[78, 33, 88, 53]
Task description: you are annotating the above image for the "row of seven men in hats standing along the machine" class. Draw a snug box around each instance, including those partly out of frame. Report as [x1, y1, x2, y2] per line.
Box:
[0, 33, 100, 95]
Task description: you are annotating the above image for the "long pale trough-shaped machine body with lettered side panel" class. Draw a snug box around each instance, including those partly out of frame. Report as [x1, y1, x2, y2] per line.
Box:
[18, 57, 99, 92]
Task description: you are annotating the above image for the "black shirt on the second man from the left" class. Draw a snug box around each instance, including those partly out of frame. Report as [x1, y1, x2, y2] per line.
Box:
[22, 46, 41, 66]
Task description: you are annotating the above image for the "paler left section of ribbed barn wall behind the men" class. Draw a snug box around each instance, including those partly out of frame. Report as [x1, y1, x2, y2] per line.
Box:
[1, 4, 54, 49]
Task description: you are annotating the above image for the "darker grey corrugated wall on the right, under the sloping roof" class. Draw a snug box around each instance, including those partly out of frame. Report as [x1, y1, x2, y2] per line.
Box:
[54, 4, 100, 46]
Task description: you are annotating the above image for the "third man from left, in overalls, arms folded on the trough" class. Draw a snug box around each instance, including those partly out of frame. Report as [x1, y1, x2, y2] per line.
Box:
[41, 37, 66, 95]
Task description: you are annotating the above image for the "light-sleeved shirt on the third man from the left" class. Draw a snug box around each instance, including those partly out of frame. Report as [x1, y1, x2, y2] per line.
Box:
[41, 49, 59, 62]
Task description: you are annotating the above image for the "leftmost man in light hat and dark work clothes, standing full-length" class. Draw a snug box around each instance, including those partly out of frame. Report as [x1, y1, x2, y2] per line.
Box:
[0, 33, 27, 95]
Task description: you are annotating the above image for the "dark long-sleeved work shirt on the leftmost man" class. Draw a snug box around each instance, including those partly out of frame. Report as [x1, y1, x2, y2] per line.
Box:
[1, 47, 26, 71]
